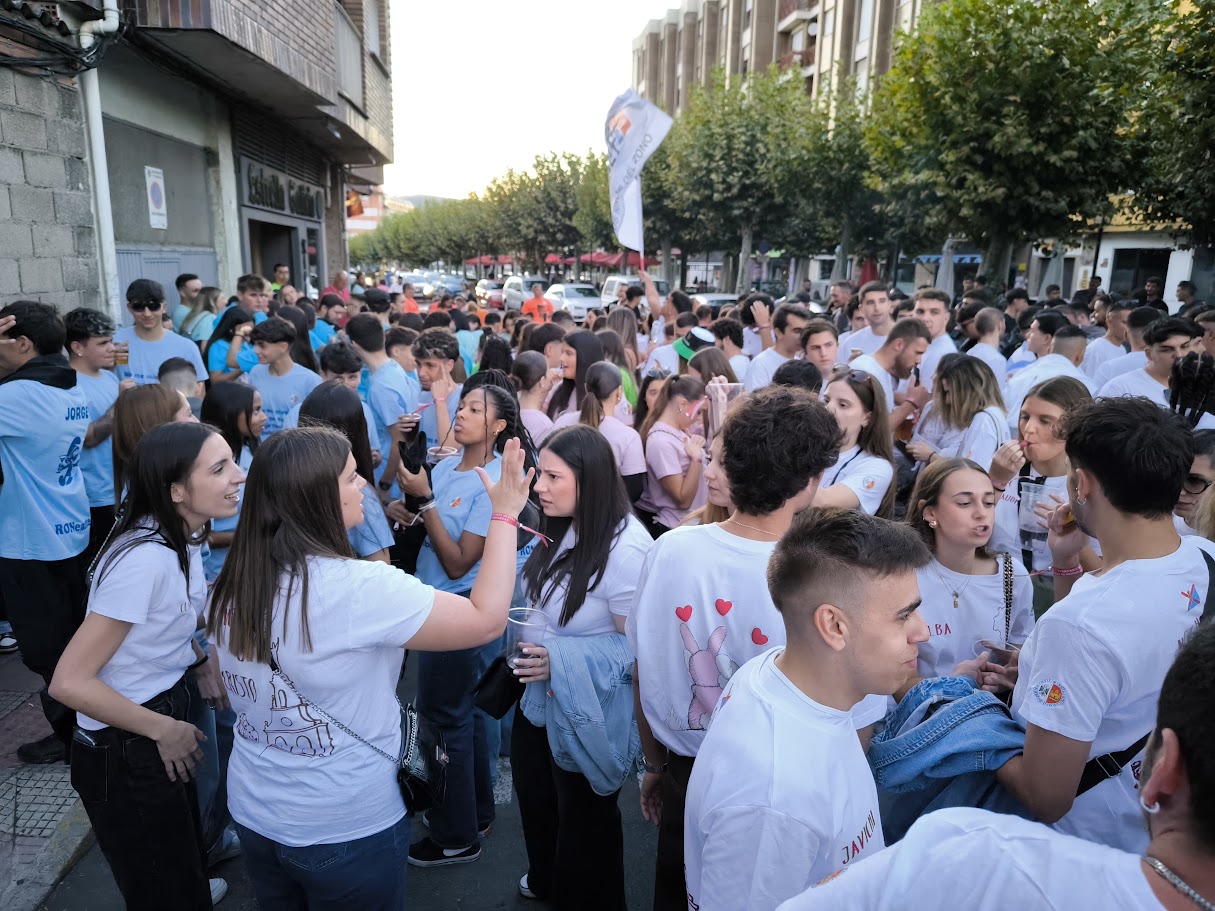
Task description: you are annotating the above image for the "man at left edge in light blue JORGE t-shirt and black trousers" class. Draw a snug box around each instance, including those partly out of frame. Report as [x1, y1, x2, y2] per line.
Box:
[0, 300, 92, 763]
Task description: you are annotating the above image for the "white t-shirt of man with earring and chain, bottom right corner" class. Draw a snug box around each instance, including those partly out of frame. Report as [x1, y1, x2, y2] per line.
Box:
[776, 807, 1164, 911]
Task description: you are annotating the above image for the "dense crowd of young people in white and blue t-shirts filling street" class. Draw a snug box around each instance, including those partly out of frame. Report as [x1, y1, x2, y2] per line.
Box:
[0, 272, 1215, 911]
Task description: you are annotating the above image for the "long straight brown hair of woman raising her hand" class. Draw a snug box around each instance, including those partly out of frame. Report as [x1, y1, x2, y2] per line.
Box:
[207, 428, 355, 664]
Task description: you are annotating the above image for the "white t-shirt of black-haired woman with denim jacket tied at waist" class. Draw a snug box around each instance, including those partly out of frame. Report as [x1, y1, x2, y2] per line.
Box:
[536, 515, 654, 635]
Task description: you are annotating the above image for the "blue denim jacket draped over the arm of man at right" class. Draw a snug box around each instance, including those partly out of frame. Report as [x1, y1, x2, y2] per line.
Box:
[869, 677, 1029, 844]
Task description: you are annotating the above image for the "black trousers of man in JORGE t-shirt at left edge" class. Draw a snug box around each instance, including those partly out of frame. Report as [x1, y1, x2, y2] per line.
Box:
[0, 556, 89, 747]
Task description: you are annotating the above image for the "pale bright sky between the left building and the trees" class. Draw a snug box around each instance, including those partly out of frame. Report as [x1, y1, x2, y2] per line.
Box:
[384, 0, 678, 197]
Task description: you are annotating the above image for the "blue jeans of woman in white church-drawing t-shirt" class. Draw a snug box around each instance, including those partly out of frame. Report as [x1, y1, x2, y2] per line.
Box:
[237, 816, 409, 911]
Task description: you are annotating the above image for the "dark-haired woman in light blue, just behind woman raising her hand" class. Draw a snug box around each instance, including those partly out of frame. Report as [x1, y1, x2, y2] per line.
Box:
[300, 380, 394, 564]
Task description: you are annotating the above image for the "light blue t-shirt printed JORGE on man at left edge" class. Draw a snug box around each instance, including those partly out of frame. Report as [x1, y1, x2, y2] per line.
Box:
[0, 374, 89, 561]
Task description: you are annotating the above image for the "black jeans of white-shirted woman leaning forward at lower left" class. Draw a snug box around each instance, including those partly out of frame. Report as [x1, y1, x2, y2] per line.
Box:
[72, 680, 211, 911]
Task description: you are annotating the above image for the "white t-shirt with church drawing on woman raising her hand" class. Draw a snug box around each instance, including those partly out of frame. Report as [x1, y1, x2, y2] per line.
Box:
[215, 558, 435, 848]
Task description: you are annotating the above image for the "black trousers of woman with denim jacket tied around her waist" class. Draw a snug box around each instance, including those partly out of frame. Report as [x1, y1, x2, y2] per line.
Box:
[510, 709, 626, 911]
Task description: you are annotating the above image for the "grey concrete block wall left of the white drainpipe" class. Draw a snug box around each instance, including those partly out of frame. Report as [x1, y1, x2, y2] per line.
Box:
[0, 58, 101, 310]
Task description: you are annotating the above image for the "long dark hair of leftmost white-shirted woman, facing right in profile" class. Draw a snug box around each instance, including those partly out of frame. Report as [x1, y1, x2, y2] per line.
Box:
[97, 421, 215, 587]
